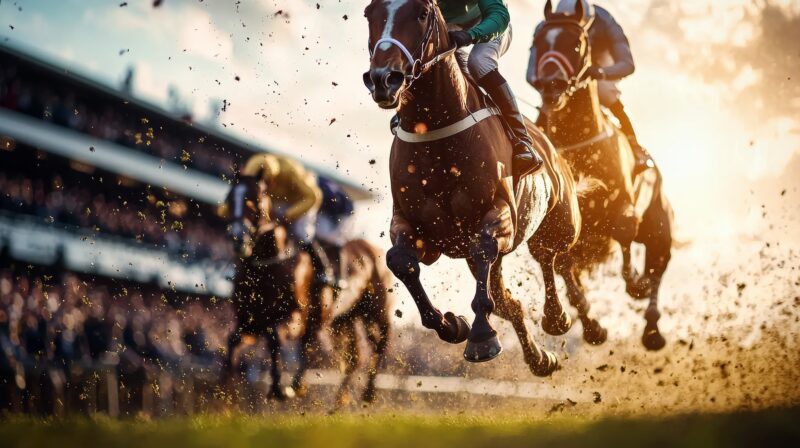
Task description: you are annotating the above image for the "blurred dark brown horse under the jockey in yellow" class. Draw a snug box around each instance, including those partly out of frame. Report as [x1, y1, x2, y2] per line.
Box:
[223, 178, 390, 403]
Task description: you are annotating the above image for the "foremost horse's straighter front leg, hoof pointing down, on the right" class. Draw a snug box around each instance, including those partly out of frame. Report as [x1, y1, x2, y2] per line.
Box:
[464, 200, 514, 362]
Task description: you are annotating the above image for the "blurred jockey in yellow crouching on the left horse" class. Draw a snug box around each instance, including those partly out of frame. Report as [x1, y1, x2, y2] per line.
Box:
[241, 154, 340, 288]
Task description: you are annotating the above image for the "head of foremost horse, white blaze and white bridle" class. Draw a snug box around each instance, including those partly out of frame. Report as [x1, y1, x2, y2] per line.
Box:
[364, 0, 449, 109]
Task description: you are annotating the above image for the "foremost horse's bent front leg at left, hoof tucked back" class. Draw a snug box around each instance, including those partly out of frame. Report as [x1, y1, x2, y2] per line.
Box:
[386, 213, 469, 344]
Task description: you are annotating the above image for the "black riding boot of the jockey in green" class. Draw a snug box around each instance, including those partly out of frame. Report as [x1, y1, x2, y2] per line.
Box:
[478, 70, 544, 178]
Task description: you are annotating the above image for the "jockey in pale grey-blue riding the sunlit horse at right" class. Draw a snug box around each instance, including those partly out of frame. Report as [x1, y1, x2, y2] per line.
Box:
[527, 0, 654, 175]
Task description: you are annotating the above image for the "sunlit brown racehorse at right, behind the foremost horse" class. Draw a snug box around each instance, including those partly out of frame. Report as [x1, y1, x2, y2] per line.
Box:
[534, 0, 672, 350]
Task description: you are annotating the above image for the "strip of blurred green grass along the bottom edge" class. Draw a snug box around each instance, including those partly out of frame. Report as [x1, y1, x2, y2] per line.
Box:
[0, 408, 800, 448]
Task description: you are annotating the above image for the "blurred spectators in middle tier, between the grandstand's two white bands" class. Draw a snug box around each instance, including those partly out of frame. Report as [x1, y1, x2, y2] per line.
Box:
[0, 171, 232, 261]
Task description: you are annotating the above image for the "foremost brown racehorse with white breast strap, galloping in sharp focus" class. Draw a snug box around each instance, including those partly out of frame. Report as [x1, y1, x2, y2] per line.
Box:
[364, 0, 603, 376]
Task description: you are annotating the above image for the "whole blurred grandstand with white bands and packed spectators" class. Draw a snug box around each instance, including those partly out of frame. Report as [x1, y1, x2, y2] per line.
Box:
[0, 46, 369, 414]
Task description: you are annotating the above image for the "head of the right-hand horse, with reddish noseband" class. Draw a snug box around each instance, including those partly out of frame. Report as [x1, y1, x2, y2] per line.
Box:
[533, 0, 591, 110]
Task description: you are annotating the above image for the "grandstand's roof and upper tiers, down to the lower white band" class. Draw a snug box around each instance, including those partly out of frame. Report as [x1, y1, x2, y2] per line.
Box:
[0, 43, 367, 295]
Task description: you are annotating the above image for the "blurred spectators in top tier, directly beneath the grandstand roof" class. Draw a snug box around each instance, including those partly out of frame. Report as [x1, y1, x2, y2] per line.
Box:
[0, 60, 236, 176]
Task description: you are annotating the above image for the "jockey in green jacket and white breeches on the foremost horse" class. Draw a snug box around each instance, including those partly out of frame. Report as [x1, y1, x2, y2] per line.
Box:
[393, 0, 543, 176]
